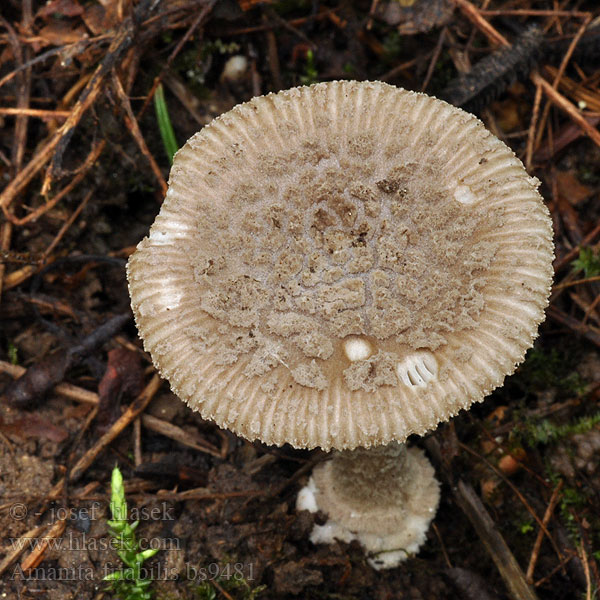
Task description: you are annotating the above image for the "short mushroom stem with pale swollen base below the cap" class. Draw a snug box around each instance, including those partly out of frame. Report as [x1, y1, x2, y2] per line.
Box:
[297, 443, 440, 569]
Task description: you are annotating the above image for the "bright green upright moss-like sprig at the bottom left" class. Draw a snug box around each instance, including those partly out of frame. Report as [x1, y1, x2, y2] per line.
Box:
[104, 467, 158, 600]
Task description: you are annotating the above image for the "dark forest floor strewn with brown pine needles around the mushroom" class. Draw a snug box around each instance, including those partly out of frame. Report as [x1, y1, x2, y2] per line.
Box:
[0, 0, 600, 600]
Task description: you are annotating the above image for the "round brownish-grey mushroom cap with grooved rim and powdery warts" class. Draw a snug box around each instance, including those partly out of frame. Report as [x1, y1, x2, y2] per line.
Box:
[127, 81, 553, 450]
